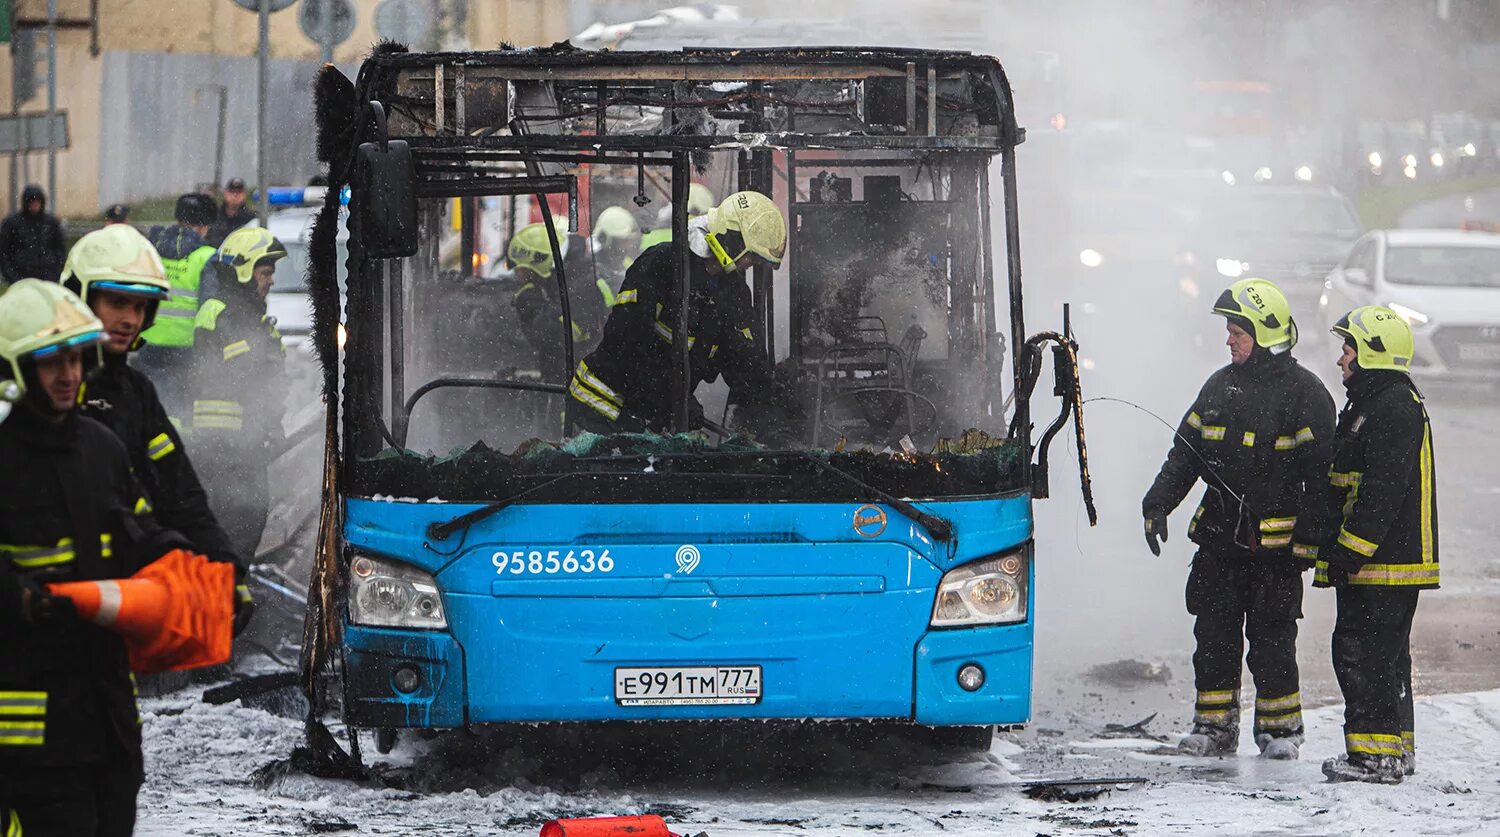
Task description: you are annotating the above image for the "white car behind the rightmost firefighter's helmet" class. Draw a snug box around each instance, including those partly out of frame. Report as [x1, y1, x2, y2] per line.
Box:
[1319, 230, 1500, 380]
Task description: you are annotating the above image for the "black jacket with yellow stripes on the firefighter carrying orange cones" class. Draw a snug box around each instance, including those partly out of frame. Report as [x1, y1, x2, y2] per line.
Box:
[0, 407, 188, 770]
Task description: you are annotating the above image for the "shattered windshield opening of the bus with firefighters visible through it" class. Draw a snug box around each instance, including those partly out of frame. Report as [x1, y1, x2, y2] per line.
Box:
[343, 153, 1019, 498]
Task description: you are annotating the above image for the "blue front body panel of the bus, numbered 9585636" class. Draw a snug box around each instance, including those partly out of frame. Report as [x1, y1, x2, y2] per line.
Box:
[345, 494, 1034, 728]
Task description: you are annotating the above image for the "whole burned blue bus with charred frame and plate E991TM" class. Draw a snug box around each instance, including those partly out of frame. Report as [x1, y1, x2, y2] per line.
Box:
[305, 47, 1086, 759]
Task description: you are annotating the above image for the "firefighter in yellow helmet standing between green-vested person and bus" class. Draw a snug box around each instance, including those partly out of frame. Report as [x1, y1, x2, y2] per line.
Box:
[192, 227, 288, 561]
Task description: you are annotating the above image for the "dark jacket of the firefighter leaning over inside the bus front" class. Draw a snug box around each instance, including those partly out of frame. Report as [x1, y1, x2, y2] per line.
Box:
[569, 243, 771, 429]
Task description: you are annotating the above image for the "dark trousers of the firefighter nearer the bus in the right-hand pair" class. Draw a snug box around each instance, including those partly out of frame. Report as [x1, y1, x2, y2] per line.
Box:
[1187, 549, 1302, 738]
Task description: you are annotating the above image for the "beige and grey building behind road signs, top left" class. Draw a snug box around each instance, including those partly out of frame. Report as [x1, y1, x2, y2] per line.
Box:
[0, 0, 569, 216]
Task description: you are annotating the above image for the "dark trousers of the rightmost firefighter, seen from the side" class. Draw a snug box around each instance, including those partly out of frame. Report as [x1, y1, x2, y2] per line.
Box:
[1334, 587, 1418, 758]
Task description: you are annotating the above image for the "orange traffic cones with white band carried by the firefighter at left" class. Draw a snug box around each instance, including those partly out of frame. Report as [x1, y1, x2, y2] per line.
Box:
[47, 549, 234, 674]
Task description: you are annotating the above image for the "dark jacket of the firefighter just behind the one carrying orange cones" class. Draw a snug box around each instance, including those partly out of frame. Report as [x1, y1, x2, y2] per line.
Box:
[81, 353, 245, 572]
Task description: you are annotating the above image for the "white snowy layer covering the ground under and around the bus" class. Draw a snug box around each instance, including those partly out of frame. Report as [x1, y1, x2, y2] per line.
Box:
[137, 690, 1500, 837]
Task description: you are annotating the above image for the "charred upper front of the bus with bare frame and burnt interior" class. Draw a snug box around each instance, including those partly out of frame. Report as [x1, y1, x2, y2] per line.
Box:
[328, 50, 1040, 503]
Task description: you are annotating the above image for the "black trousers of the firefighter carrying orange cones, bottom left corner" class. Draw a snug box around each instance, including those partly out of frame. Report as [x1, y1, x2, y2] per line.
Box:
[0, 761, 143, 837]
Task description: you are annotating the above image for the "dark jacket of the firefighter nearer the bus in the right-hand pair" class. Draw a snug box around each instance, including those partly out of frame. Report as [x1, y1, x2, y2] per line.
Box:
[1142, 348, 1335, 560]
